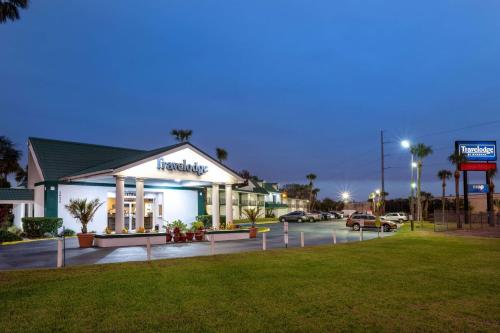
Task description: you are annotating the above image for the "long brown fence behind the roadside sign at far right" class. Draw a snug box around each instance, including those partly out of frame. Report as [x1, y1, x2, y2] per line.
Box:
[434, 210, 500, 231]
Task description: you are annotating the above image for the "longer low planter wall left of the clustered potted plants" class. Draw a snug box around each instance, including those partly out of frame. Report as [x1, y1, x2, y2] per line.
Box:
[94, 232, 167, 247]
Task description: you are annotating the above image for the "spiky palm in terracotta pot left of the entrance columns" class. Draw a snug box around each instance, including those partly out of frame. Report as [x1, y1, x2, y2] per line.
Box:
[64, 199, 104, 248]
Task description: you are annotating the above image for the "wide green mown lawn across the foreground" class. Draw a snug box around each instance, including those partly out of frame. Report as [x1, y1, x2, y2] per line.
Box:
[0, 227, 500, 332]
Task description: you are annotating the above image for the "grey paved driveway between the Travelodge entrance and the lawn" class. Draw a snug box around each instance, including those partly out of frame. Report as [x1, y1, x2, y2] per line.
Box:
[0, 221, 394, 270]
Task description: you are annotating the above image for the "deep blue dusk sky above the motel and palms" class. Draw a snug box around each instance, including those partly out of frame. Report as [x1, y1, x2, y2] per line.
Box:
[0, 0, 500, 200]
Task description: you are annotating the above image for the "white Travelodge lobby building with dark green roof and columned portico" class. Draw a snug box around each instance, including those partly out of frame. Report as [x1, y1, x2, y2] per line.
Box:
[0, 138, 245, 233]
